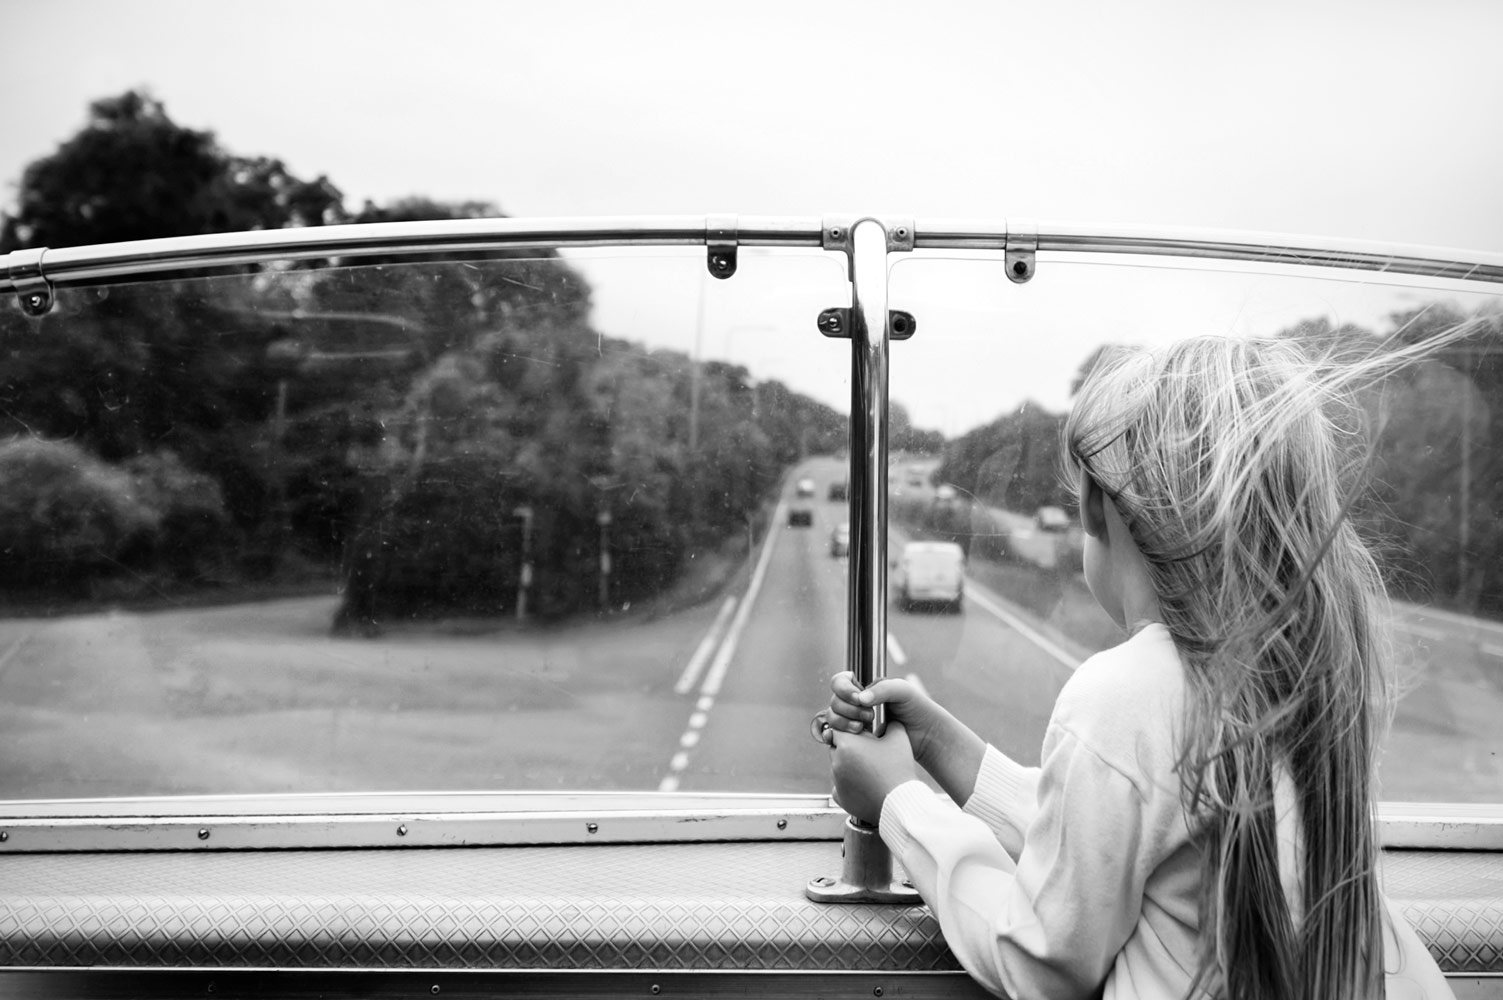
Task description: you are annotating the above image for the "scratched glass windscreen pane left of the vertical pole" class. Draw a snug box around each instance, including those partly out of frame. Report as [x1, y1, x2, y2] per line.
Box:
[0, 248, 849, 800]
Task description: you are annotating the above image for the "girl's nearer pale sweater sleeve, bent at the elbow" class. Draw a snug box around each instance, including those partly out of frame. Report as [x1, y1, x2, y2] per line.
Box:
[879, 729, 1157, 997]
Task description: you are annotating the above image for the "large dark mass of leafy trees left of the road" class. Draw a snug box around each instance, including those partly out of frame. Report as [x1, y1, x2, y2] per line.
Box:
[0, 92, 846, 632]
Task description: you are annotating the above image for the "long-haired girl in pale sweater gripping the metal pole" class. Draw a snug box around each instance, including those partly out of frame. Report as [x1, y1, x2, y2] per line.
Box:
[827, 338, 1450, 1000]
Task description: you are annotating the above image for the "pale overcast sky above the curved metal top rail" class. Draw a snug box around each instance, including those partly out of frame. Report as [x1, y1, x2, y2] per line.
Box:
[0, 0, 1503, 433]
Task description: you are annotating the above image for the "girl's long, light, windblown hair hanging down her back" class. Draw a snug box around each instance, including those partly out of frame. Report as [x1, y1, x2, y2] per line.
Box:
[1064, 337, 1392, 1000]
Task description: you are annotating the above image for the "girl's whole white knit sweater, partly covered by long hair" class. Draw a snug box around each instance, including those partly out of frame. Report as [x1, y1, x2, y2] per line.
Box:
[879, 624, 1450, 1000]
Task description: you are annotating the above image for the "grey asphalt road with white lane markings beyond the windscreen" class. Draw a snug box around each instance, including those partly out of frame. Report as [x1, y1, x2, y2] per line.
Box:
[0, 459, 1503, 802]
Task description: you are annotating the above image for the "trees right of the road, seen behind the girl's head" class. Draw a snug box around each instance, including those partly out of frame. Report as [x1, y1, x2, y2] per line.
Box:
[921, 314, 1503, 617]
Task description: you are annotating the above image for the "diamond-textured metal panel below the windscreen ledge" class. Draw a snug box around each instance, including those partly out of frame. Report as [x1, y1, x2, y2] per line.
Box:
[0, 842, 1503, 974]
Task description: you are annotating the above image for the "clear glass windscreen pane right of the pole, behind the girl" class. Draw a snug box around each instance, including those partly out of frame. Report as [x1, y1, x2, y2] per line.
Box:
[888, 254, 1503, 803]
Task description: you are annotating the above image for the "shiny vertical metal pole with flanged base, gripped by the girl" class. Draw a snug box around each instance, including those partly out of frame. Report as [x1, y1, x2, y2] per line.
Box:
[804, 220, 921, 905]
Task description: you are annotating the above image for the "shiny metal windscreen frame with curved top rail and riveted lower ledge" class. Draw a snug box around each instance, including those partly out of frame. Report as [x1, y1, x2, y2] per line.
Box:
[0, 215, 1503, 853]
